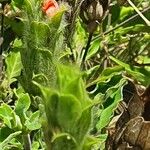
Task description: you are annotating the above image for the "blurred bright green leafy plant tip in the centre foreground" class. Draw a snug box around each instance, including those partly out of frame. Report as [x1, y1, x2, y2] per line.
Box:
[36, 65, 92, 149]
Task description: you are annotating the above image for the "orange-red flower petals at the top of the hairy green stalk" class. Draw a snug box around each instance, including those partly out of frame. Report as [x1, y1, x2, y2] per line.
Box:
[42, 0, 59, 17]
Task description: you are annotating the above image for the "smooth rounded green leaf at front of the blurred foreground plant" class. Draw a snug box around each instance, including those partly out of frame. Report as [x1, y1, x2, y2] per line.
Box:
[56, 94, 82, 132]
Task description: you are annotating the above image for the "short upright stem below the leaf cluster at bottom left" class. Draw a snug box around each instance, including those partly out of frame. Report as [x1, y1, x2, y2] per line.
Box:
[23, 134, 31, 150]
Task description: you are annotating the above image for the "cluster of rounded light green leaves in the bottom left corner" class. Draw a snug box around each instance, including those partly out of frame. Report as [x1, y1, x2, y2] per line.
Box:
[0, 93, 41, 149]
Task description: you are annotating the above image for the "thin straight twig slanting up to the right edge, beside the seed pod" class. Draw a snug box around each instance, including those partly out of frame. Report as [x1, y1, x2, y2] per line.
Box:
[93, 7, 150, 41]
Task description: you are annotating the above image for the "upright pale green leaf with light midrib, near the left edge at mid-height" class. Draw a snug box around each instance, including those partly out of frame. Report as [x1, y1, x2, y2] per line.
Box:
[6, 51, 22, 84]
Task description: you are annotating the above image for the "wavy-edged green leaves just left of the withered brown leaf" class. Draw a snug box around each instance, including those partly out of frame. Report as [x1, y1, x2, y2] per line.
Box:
[88, 66, 126, 139]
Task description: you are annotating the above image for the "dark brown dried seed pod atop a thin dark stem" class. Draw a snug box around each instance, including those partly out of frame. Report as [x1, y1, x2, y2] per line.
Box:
[80, 0, 108, 33]
